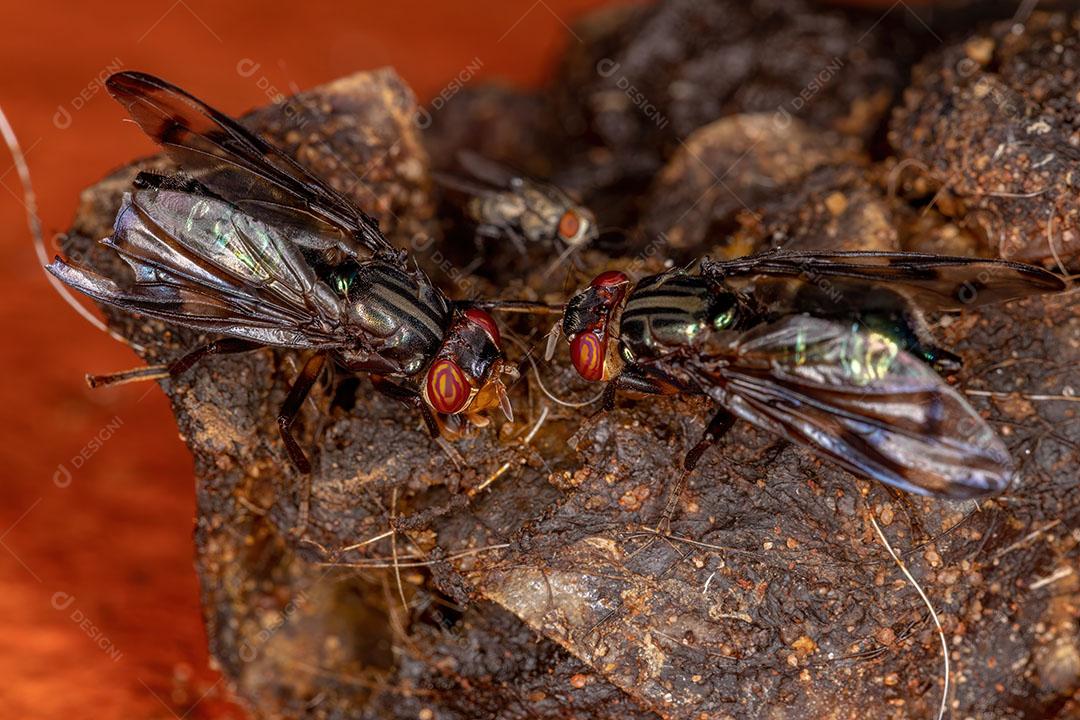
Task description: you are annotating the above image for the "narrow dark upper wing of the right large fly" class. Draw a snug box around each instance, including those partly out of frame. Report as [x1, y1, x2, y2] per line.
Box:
[701, 252, 1066, 310]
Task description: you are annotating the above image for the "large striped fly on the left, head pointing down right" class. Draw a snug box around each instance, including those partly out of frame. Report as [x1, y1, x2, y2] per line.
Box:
[48, 72, 515, 472]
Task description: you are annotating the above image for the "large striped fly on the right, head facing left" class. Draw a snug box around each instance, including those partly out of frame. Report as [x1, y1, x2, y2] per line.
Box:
[549, 252, 1065, 498]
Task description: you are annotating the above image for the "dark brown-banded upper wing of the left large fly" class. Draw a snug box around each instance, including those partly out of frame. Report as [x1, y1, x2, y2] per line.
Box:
[106, 72, 403, 262]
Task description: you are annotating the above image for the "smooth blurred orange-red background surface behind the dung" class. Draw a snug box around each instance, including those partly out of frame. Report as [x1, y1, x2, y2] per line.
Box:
[0, 0, 635, 720]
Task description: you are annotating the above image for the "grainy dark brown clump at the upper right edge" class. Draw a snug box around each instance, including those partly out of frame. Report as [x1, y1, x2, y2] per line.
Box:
[889, 13, 1080, 267]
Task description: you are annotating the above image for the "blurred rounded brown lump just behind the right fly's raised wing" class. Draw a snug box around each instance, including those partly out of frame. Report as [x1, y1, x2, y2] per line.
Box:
[642, 113, 897, 260]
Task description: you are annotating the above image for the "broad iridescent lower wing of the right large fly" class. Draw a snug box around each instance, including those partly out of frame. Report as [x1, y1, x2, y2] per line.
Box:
[690, 315, 1013, 498]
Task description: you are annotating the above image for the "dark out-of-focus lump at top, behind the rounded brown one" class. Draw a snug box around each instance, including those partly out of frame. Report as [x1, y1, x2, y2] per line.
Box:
[548, 0, 911, 231]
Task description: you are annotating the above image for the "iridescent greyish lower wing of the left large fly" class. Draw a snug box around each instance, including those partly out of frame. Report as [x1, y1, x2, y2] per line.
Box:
[48, 184, 348, 349]
